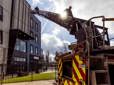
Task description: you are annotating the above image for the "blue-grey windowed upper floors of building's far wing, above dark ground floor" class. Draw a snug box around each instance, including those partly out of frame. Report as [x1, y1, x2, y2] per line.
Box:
[28, 16, 41, 56]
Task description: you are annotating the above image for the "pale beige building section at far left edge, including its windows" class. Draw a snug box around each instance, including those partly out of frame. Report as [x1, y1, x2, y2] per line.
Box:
[0, 0, 12, 75]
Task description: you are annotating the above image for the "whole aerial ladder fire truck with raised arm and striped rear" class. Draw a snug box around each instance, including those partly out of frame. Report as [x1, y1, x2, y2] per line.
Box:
[31, 7, 114, 85]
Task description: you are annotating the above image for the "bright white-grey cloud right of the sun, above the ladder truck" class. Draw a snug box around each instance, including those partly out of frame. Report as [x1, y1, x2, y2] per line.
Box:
[53, 0, 114, 34]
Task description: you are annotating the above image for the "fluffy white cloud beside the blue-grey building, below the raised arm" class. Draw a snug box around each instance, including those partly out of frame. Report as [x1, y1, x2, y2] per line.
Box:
[42, 33, 63, 52]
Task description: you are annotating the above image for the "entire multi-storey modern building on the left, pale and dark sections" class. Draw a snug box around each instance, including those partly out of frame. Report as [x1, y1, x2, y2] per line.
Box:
[0, 0, 41, 74]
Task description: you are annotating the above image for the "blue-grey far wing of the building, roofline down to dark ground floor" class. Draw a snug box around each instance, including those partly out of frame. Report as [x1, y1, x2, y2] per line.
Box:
[27, 15, 41, 72]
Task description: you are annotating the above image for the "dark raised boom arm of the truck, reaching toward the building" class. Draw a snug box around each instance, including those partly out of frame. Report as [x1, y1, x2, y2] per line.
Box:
[31, 7, 109, 49]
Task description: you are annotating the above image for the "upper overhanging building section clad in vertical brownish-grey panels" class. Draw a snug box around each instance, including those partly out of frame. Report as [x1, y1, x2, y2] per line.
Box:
[12, 0, 31, 34]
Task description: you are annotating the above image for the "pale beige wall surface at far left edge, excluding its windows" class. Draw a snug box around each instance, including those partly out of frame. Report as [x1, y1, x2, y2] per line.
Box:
[0, 0, 12, 73]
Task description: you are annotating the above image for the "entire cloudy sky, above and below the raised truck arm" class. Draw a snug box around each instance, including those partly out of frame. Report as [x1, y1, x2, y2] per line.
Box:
[27, 0, 114, 60]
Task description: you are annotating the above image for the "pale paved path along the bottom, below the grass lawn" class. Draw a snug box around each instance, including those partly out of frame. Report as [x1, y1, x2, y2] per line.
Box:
[3, 80, 54, 85]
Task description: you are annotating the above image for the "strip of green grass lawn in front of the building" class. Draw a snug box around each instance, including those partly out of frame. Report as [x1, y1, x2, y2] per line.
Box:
[3, 72, 55, 83]
